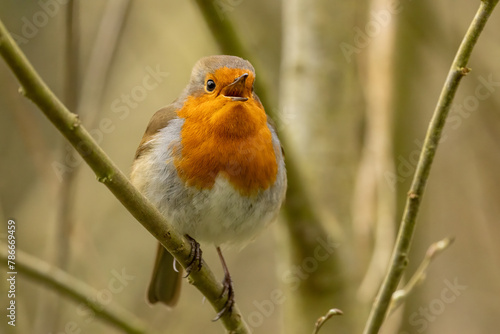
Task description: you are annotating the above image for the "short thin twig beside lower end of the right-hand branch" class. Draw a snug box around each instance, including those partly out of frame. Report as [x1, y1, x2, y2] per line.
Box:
[387, 238, 454, 315]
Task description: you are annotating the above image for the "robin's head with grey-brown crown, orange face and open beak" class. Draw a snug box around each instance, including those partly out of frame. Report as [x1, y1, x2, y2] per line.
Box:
[179, 56, 267, 136]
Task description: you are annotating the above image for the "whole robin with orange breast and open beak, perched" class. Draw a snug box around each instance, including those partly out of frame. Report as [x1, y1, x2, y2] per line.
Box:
[131, 56, 287, 319]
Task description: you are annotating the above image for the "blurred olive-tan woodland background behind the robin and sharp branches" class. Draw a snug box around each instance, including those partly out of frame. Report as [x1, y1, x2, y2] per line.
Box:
[0, 0, 500, 334]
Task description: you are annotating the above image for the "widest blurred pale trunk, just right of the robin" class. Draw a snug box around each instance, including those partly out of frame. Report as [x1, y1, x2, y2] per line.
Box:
[279, 0, 361, 334]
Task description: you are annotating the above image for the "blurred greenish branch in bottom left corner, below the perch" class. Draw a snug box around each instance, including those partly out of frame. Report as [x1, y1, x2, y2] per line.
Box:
[0, 243, 147, 333]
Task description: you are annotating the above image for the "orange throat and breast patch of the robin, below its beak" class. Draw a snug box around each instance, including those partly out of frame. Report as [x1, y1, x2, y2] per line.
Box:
[174, 92, 278, 196]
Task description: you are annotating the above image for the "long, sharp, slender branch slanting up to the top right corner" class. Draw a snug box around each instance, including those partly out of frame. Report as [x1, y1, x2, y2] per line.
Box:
[364, 0, 498, 334]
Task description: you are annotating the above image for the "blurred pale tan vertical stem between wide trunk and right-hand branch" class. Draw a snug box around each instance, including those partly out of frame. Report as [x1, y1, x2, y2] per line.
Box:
[352, 0, 399, 314]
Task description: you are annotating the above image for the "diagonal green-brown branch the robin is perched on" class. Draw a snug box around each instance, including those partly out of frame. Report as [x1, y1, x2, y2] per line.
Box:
[0, 21, 249, 333]
